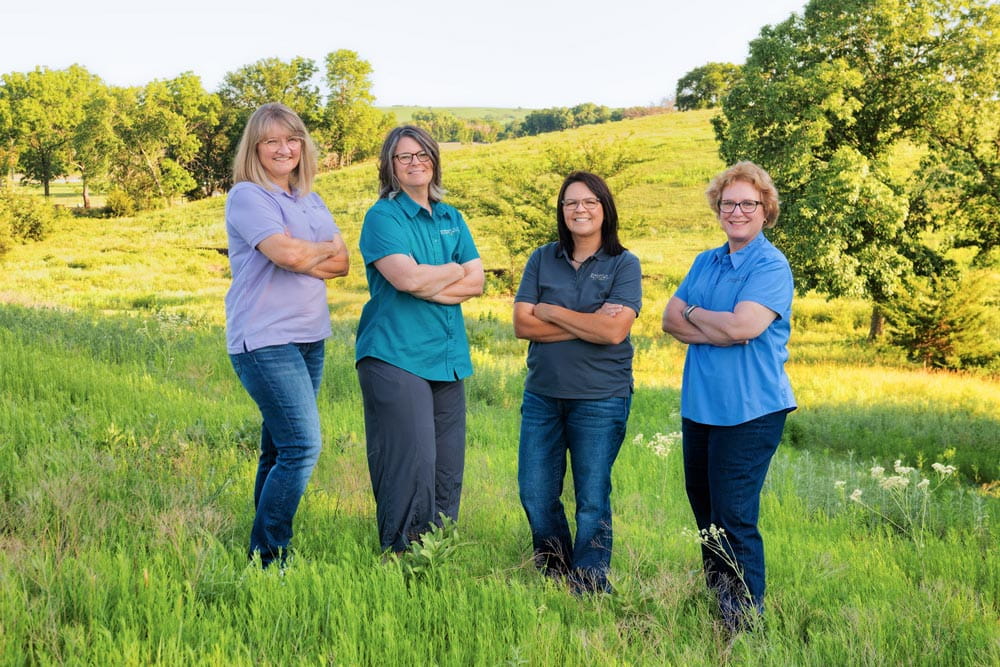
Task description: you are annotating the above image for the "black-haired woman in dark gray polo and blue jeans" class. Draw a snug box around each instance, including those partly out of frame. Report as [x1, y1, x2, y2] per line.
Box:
[514, 171, 642, 593]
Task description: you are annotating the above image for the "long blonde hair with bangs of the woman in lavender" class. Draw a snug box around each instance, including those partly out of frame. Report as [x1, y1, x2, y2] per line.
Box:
[233, 102, 316, 197]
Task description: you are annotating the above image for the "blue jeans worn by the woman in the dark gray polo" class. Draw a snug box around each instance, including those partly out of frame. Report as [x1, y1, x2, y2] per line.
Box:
[517, 391, 632, 591]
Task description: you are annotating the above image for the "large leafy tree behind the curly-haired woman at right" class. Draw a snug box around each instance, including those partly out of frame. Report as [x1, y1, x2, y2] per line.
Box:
[713, 0, 1000, 338]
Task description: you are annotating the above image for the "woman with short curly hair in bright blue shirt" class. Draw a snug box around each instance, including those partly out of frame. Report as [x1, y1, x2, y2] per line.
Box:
[663, 162, 796, 631]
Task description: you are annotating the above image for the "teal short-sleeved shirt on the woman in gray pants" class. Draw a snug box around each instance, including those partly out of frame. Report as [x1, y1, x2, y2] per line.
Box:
[355, 192, 479, 381]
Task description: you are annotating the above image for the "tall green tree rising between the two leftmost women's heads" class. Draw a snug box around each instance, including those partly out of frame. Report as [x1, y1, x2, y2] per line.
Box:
[321, 49, 395, 167]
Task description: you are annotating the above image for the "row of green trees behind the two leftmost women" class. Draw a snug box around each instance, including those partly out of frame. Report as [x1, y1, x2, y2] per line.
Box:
[0, 50, 395, 213]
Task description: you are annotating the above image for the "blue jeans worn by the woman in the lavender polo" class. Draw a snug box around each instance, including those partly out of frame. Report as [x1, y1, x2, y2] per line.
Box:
[229, 341, 324, 567]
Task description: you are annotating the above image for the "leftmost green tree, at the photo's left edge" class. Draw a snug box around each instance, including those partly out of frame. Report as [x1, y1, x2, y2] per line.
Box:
[2, 65, 103, 197]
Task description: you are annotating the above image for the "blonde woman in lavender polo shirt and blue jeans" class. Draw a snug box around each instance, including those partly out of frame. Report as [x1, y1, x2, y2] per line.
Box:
[226, 104, 348, 567]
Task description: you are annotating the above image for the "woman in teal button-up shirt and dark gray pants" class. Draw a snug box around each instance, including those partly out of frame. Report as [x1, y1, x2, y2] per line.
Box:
[356, 125, 484, 553]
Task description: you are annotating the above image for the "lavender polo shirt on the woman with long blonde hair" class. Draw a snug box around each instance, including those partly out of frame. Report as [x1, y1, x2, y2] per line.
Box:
[226, 181, 340, 354]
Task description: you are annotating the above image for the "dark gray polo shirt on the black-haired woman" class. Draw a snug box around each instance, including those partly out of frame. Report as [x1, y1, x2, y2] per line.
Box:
[514, 243, 642, 399]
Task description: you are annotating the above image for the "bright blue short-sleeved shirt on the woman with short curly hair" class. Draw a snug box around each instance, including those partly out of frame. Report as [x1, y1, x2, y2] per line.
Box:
[676, 234, 796, 426]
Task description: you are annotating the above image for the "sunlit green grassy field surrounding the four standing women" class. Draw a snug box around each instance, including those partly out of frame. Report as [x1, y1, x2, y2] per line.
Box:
[0, 113, 1000, 665]
